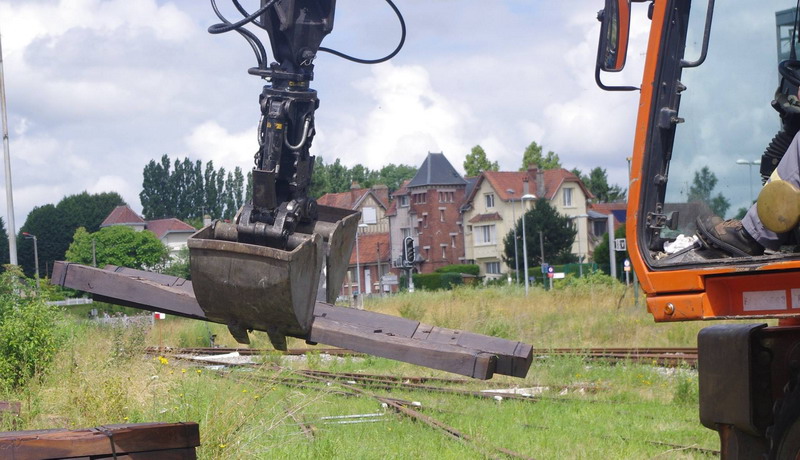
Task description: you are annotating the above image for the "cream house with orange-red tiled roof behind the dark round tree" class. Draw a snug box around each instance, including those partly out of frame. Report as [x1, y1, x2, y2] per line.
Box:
[462, 168, 593, 278]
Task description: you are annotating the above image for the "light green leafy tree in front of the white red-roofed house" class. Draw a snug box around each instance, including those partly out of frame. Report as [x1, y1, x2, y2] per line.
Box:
[66, 225, 169, 270]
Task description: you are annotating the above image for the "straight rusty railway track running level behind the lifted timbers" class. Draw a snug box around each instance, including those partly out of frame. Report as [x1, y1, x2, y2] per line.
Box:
[147, 347, 697, 367]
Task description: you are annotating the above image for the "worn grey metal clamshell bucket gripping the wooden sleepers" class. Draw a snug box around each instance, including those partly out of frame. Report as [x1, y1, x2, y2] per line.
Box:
[188, 206, 359, 350]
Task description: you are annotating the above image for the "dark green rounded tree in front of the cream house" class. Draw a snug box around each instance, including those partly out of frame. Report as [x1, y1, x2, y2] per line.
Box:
[503, 198, 578, 267]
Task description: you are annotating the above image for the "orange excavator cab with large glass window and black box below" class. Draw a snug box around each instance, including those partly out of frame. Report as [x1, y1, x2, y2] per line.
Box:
[595, 0, 800, 452]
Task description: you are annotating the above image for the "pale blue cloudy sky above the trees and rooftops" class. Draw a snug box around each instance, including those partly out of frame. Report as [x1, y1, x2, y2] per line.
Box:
[0, 0, 649, 229]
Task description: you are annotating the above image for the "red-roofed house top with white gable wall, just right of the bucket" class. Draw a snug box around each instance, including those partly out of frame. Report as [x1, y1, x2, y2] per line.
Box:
[317, 182, 389, 233]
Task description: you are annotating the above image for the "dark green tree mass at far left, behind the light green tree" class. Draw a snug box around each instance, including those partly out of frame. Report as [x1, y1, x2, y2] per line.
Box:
[17, 192, 125, 276]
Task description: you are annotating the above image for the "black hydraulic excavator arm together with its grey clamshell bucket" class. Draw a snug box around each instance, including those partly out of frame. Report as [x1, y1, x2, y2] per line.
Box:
[188, 0, 346, 350]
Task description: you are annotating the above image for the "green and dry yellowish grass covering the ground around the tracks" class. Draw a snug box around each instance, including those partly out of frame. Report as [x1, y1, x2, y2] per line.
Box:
[0, 287, 719, 459]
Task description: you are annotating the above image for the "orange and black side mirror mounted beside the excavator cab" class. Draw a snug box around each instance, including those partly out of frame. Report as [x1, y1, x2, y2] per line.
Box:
[597, 0, 631, 72]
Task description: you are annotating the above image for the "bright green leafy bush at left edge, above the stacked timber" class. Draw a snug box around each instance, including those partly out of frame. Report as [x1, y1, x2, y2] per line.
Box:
[0, 265, 62, 389]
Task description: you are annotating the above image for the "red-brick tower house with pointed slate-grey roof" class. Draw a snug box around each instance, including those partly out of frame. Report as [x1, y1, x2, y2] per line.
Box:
[387, 152, 470, 273]
